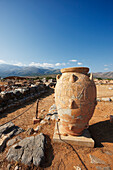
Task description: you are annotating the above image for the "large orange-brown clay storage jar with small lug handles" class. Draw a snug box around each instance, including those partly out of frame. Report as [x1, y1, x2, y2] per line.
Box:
[55, 67, 96, 136]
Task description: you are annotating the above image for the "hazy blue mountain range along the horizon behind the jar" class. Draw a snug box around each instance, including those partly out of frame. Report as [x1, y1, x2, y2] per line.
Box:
[0, 64, 113, 79]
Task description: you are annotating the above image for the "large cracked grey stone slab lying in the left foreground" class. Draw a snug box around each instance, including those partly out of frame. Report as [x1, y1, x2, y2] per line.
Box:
[7, 133, 46, 166]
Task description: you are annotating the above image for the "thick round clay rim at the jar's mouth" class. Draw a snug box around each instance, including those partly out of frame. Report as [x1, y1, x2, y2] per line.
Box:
[60, 67, 89, 74]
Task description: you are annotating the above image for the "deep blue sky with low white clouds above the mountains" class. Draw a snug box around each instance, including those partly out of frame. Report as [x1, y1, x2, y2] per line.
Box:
[0, 0, 113, 72]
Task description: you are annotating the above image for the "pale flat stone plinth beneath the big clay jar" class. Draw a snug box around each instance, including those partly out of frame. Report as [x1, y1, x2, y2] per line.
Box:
[53, 122, 94, 147]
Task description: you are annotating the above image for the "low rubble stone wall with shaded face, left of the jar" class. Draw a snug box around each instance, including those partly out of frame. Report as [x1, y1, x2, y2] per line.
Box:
[0, 83, 49, 112]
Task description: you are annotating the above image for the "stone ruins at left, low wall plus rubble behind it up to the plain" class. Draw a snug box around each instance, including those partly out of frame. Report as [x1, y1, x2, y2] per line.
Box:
[0, 78, 55, 112]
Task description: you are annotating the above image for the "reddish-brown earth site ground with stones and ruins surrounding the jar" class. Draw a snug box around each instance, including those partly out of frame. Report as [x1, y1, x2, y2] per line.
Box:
[0, 79, 113, 170]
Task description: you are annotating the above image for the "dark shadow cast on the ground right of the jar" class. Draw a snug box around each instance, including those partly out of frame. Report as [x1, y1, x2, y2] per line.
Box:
[89, 120, 113, 147]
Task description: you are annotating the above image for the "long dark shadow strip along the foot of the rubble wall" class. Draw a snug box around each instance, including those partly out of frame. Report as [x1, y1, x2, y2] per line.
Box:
[0, 88, 54, 119]
